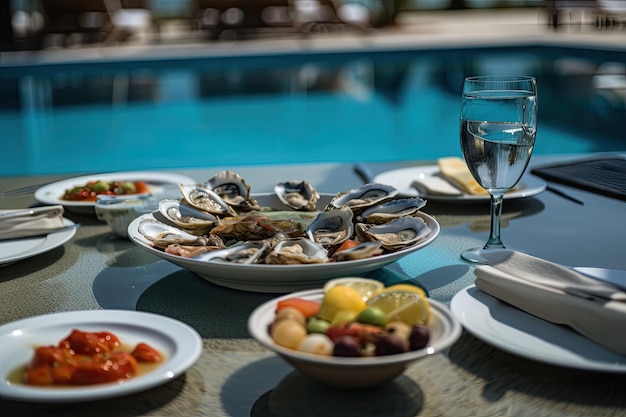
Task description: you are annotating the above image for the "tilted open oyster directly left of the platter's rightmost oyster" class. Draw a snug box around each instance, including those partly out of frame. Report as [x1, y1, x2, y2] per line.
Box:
[305, 207, 354, 248]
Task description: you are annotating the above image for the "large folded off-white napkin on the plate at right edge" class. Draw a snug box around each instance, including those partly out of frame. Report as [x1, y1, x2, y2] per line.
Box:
[474, 249, 626, 355]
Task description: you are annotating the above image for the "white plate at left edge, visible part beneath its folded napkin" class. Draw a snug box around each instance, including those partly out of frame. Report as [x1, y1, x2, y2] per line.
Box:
[0, 218, 76, 266]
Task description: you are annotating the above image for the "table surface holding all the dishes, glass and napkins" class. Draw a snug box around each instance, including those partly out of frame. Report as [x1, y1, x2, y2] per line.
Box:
[0, 154, 626, 417]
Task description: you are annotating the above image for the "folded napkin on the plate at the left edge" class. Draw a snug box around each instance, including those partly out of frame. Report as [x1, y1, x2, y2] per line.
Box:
[0, 205, 65, 240]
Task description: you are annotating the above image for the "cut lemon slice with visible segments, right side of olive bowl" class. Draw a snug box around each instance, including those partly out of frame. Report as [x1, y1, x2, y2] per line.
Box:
[367, 287, 430, 326]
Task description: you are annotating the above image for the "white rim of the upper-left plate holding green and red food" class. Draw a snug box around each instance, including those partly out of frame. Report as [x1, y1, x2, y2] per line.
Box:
[35, 171, 197, 208]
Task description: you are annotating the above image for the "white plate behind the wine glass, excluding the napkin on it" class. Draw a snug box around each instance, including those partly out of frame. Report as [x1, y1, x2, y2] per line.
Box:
[374, 165, 547, 203]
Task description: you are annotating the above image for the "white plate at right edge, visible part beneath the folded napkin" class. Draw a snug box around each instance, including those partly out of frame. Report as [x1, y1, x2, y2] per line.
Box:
[450, 271, 626, 373]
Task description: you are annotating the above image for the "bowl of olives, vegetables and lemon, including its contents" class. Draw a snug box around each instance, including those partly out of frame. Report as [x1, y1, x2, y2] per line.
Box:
[248, 285, 461, 388]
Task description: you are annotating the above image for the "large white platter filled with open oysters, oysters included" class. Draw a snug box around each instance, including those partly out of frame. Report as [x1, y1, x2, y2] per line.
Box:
[128, 171, 440, 293]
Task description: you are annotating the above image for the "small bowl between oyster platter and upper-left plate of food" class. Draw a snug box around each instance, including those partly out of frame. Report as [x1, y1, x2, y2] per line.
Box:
[94, 195, 159, 237]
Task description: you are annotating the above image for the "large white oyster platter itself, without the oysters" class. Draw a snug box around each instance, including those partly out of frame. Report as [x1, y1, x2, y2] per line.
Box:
[128, 194, 440, 293]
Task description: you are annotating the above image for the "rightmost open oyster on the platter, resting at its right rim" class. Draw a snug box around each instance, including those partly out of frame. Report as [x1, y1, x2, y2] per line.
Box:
[355, 217, 431, 251]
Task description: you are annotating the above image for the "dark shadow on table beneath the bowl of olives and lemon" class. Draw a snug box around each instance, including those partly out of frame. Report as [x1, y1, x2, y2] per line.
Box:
[221, 357, 424, 417]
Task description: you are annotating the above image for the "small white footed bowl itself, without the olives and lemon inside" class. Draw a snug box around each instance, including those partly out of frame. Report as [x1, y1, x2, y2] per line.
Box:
[248, 289, 461, 388]
